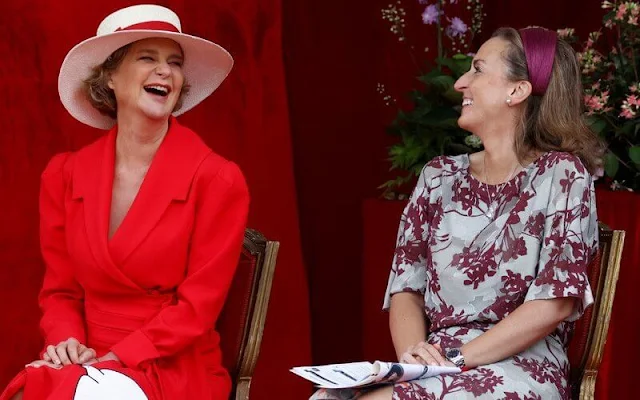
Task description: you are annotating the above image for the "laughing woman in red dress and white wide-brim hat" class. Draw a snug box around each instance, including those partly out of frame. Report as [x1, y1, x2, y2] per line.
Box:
[0, 5, 249, 400]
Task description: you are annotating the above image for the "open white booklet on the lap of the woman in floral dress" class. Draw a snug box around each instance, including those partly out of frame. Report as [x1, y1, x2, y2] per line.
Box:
[291, 361, 461, 389]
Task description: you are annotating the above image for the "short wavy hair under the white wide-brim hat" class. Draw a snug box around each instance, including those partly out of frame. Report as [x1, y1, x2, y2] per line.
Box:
[84, 43, 189, 119]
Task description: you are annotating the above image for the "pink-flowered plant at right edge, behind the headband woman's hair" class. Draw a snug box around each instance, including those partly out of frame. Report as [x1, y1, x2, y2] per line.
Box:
[558, 1, 640, 191]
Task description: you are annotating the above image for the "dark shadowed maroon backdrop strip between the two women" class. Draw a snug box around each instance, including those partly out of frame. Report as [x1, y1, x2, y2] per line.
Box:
[283, 0, 413, 363]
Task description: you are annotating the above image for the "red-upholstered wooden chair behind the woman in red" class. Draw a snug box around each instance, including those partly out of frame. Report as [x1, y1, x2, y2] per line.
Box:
[217, 229, 280, 400]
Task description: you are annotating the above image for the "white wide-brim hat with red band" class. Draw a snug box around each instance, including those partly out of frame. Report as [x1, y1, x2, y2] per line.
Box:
[58, 4, 233, 129]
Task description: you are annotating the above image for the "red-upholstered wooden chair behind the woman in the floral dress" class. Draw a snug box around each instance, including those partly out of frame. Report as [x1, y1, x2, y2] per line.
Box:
[569, 224, 625, 400]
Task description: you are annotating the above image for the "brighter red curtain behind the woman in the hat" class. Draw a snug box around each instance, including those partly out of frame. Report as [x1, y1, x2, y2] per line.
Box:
[0, 0, 310, 399]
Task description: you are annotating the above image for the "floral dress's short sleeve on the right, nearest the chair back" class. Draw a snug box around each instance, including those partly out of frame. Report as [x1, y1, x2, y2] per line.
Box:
[525, 158, 598, 321]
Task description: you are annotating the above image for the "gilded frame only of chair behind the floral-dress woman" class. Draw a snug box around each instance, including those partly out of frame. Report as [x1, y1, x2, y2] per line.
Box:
[578, 224, 625, 400]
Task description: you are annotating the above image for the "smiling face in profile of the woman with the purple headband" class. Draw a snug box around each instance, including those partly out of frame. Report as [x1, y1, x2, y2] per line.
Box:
[455, 38, 514, 134]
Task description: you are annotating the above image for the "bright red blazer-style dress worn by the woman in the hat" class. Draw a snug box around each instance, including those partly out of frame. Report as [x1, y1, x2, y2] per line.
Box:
[0, 118, 249, 400]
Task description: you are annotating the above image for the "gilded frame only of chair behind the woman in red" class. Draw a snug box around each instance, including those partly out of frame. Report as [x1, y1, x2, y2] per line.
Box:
[235, 229, 280, 400]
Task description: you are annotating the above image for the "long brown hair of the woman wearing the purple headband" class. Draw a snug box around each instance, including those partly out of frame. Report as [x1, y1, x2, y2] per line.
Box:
[491, 28, 605, 174]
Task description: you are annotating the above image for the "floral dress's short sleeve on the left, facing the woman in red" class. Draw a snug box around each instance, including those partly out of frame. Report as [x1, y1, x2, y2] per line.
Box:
[383, 162, 429, 310]
